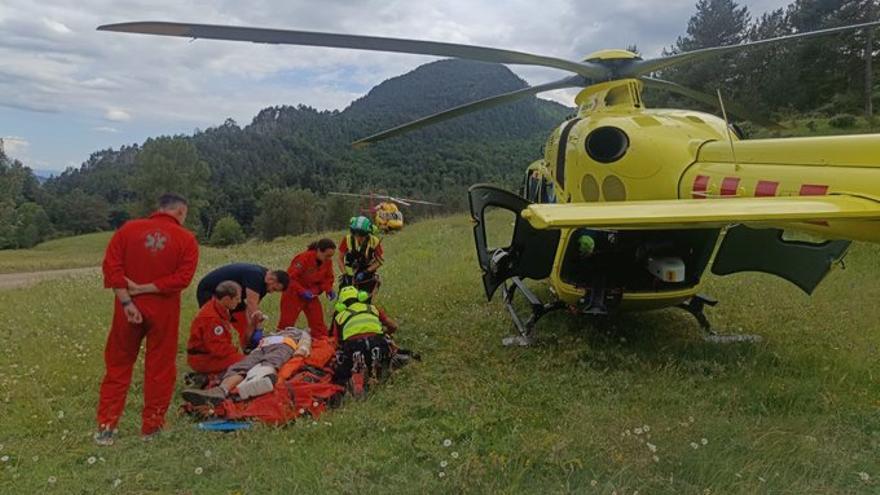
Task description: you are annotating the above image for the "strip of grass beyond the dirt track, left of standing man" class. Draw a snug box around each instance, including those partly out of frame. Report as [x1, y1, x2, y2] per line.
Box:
[0, 232, 112, 273]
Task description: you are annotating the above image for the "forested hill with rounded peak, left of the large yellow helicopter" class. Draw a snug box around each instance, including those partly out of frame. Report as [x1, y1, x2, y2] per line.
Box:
[29, 60, 572, 245]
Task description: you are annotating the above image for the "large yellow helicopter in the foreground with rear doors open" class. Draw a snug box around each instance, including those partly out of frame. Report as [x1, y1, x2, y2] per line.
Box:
[98, 22, 880, 345]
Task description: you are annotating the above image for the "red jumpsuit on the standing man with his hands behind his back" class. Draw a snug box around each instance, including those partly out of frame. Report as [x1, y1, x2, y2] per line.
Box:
[98, 212, 199, 435]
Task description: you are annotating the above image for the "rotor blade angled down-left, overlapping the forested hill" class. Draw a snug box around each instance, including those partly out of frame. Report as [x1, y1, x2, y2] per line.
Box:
[352, 76, 589, 148]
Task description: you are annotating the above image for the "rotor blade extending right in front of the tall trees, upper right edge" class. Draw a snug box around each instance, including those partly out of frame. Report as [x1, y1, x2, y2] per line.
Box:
[615, 21, 880, 78]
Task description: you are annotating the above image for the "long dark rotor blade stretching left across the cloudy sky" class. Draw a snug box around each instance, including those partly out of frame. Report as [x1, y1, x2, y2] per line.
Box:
[98, 21, 610, 79]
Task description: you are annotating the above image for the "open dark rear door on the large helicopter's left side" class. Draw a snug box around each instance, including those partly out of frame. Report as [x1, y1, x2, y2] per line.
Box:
[468, 184, 560, 300]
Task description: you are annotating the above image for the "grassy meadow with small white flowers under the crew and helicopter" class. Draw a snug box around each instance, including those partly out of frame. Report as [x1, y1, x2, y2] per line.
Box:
[0, 216, 880, 494]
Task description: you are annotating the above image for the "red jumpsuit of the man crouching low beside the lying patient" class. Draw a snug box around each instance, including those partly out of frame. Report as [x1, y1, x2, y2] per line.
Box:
[186, 298, 244, 373]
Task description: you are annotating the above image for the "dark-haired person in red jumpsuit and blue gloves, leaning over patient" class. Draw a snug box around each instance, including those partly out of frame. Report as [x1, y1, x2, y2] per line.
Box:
[278, 239, 336, 339]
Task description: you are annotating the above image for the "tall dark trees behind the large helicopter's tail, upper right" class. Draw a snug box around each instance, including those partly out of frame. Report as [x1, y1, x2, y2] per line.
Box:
[649, 0, 880, 125]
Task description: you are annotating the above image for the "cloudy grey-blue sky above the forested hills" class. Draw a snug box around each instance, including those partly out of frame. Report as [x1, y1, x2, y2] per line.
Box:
[0, 0, 789, 170]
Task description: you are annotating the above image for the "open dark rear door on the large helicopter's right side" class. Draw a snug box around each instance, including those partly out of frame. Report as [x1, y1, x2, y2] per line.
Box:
[712, 225, 850, 294]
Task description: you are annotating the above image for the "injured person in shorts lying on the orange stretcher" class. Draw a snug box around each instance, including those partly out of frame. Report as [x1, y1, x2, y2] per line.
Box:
[183, 327, 312, 406]
